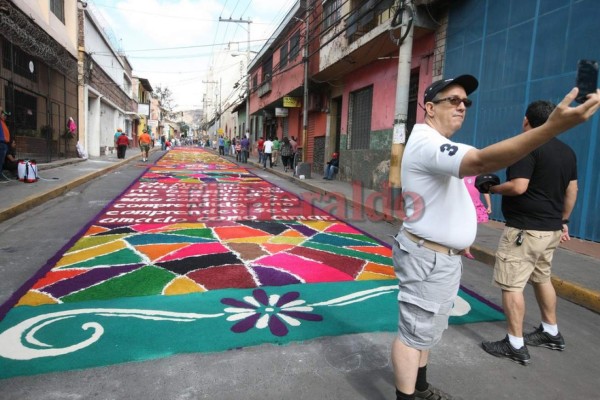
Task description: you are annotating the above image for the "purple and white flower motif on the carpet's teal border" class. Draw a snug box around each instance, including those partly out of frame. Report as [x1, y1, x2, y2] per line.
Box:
[221, 289, 323, 336]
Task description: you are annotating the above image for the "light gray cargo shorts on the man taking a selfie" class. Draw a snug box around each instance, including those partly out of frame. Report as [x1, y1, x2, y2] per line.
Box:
[392, 231, 462, 350]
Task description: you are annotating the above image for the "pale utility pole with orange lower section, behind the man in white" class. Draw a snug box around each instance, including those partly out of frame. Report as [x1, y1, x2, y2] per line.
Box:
[389, 0, 413, 205]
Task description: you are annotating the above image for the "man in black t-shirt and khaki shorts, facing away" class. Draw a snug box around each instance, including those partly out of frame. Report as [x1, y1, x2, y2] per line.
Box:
[482, 101, 577, 365]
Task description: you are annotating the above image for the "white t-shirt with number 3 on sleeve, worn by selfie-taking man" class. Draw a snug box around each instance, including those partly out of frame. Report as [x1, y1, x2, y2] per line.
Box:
[401, 124, 477, 249]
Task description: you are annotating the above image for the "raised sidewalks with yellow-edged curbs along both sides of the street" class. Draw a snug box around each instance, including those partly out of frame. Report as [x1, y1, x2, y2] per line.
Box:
[0, 149, 600, 312]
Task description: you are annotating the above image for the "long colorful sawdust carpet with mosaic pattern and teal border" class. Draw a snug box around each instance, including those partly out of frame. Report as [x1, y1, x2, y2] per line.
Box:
[0, 149, 503, 378]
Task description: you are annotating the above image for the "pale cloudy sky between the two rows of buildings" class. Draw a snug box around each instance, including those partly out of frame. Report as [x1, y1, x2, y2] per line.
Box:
[87, 0, 297, 111]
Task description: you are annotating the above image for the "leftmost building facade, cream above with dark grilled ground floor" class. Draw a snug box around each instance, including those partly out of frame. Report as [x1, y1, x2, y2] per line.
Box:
[0, 0, 80, 162]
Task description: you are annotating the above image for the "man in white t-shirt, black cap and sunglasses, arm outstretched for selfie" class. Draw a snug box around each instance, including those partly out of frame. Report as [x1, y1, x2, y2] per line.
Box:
[392, 75, 600, 400]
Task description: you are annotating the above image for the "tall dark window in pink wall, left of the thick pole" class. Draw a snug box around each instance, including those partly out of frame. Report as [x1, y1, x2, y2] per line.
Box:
[348, 86, 373, 150]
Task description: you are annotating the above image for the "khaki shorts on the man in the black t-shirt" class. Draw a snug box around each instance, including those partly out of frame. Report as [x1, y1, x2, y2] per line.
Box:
[492, 227, 562, 292]
